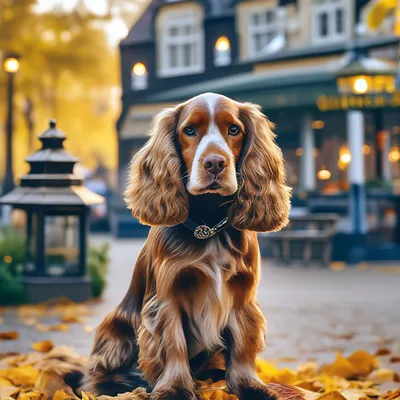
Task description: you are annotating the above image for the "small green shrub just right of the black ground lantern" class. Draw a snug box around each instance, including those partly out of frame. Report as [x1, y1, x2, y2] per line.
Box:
[88, 243, 110, 298]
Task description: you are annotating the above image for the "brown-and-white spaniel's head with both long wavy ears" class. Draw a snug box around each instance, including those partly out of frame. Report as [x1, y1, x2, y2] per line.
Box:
[126, 93, 290, 231]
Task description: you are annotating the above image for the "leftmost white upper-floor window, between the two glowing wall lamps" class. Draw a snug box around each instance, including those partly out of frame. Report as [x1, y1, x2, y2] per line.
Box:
[157, 4, 204, 77]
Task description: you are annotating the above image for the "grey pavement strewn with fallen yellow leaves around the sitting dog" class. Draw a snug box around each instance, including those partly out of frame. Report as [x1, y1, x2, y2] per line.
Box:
[0, 239, 400, 400]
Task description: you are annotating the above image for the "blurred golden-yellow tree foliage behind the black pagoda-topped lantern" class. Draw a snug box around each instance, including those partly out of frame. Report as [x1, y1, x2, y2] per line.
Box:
[0, 0, 146, 182]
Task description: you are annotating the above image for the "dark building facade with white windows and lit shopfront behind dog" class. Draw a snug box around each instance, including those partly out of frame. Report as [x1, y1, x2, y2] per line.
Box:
[117, 0, 400, 259]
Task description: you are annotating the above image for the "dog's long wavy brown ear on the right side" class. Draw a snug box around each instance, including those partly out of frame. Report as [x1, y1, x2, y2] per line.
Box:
[230, 103, 291, 232]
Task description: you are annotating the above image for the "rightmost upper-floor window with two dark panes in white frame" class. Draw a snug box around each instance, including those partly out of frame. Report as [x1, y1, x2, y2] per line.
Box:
[311, 0, 348, 44]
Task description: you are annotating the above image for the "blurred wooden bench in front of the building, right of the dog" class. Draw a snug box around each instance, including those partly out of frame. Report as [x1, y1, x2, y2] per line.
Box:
[268, 214, 339, 266]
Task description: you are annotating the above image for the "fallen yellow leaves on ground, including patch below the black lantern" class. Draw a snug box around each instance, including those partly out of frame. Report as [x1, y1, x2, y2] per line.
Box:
[0, 300, 400, 400]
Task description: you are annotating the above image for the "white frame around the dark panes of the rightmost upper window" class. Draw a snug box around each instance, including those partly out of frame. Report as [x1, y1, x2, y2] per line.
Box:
[311, 0, 353, 45]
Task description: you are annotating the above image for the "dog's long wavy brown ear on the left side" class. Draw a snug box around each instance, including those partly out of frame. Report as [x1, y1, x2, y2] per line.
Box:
[125, 106, 189, 226]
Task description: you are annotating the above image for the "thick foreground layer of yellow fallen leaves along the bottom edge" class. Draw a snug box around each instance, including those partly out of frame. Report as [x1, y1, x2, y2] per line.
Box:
[0, 342, 400, 400]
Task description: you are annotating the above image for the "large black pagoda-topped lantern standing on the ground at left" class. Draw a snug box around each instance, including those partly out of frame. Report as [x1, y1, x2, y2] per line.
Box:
[0, 120, 104, 302]
